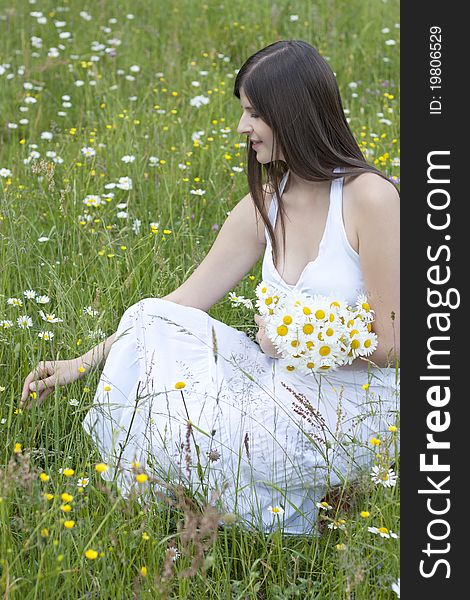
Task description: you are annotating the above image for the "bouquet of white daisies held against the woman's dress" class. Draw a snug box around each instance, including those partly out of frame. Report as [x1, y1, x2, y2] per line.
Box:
[256, 281, 377, 374]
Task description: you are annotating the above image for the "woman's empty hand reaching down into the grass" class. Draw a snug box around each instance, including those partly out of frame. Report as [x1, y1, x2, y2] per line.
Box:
[20, 358, 85, 408]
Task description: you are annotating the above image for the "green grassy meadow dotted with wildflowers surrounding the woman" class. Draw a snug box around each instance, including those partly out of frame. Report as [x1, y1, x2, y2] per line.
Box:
[0, 0, 400, 600]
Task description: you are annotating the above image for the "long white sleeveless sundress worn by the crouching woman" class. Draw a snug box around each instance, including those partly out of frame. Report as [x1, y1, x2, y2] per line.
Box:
[83, 172, 399, 534]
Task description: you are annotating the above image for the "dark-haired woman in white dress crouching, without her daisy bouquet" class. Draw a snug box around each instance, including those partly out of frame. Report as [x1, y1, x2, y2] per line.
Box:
[22, 40, 399, 533]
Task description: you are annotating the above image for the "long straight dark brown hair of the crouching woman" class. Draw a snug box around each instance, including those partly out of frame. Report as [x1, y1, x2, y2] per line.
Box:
[233, 40, 393, 264]
